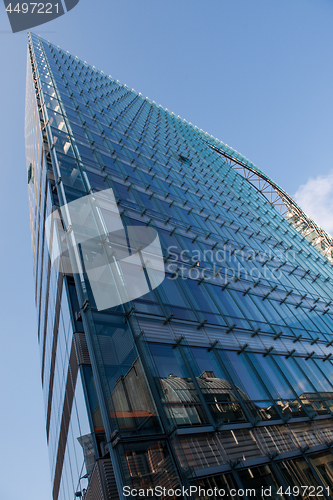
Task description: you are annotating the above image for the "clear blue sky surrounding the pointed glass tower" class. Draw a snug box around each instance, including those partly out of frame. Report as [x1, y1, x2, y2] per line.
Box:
[0, 0, 333, 500]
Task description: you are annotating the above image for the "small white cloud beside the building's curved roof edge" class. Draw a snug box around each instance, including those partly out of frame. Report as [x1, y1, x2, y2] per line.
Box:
[293, 171, 333, 234]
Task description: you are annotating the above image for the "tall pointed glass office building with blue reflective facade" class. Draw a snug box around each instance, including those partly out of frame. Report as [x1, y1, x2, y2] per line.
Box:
[25, 34, 333, 500]
